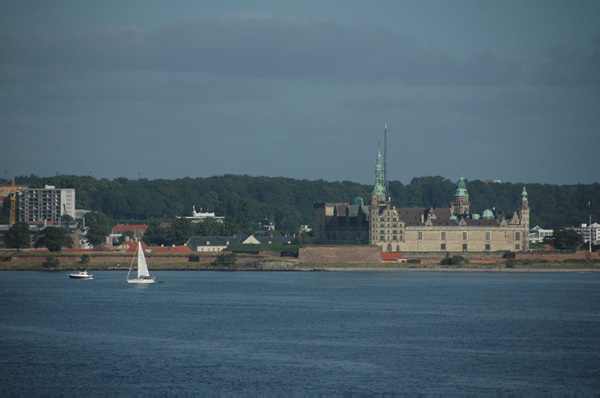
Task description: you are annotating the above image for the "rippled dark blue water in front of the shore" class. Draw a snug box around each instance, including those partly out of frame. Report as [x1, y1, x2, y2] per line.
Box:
[0, 272, 600, 396]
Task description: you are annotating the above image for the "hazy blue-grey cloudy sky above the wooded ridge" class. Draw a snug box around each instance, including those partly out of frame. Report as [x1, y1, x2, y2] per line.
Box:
[0, 0, 600, 185]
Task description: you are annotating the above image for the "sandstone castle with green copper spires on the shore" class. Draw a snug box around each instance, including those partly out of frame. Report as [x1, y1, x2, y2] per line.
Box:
[314, 146, 529, 252]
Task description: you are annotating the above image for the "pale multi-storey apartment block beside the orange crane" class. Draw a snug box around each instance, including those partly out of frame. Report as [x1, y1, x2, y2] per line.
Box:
[19, 185, 75, 223]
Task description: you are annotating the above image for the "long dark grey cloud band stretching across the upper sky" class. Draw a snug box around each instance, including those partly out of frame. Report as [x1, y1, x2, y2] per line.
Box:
[0, 16, 522, 85]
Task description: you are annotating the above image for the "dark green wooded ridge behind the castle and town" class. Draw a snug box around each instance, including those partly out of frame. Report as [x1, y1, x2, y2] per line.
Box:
[5, 175, 600, 233]
